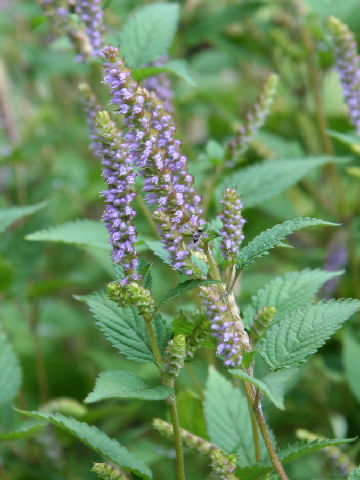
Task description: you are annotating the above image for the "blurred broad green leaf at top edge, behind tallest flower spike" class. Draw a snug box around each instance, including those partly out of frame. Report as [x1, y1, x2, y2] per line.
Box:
[119, 3, 179, 68]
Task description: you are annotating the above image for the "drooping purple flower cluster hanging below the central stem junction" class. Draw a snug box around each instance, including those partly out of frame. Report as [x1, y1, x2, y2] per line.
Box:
[200, 285, 242, 367]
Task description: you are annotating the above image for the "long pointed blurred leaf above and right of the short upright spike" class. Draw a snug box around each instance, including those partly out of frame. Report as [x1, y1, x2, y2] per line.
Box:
[218, 157, 339, 208]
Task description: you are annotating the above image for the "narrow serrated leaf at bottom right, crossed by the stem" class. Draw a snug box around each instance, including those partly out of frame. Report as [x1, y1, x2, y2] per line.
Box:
[236, 438, 354, 480]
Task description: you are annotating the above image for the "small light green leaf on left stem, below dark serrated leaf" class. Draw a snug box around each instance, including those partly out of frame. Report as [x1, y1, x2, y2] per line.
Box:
[85, 370, 174, 403]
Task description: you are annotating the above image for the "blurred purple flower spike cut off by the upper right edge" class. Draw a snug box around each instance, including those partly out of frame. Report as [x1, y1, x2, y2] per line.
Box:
[329, 17, 360, 135]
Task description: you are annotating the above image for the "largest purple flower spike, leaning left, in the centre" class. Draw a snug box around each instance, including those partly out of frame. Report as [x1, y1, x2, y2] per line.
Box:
[103, 46, 205, 275]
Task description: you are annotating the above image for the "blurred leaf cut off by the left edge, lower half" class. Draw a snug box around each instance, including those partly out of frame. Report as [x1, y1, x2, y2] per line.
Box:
[0, 331, 22, 405]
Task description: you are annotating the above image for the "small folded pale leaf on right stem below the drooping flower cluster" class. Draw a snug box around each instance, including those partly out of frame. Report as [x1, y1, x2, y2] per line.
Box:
[230, 368, 298, 410]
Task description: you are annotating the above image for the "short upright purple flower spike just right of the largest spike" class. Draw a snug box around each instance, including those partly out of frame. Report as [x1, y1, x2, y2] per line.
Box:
[220, 188, 245, 263]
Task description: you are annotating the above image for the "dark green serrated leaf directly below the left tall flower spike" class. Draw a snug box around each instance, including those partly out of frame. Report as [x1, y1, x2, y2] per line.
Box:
[77, 293, 154, 363]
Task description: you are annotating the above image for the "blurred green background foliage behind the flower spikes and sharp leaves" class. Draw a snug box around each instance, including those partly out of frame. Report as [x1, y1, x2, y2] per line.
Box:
[0, 0, 360, 480]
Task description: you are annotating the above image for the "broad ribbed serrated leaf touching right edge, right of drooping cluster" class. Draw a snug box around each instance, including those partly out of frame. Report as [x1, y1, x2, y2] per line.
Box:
[257, 299, 360, 370]
